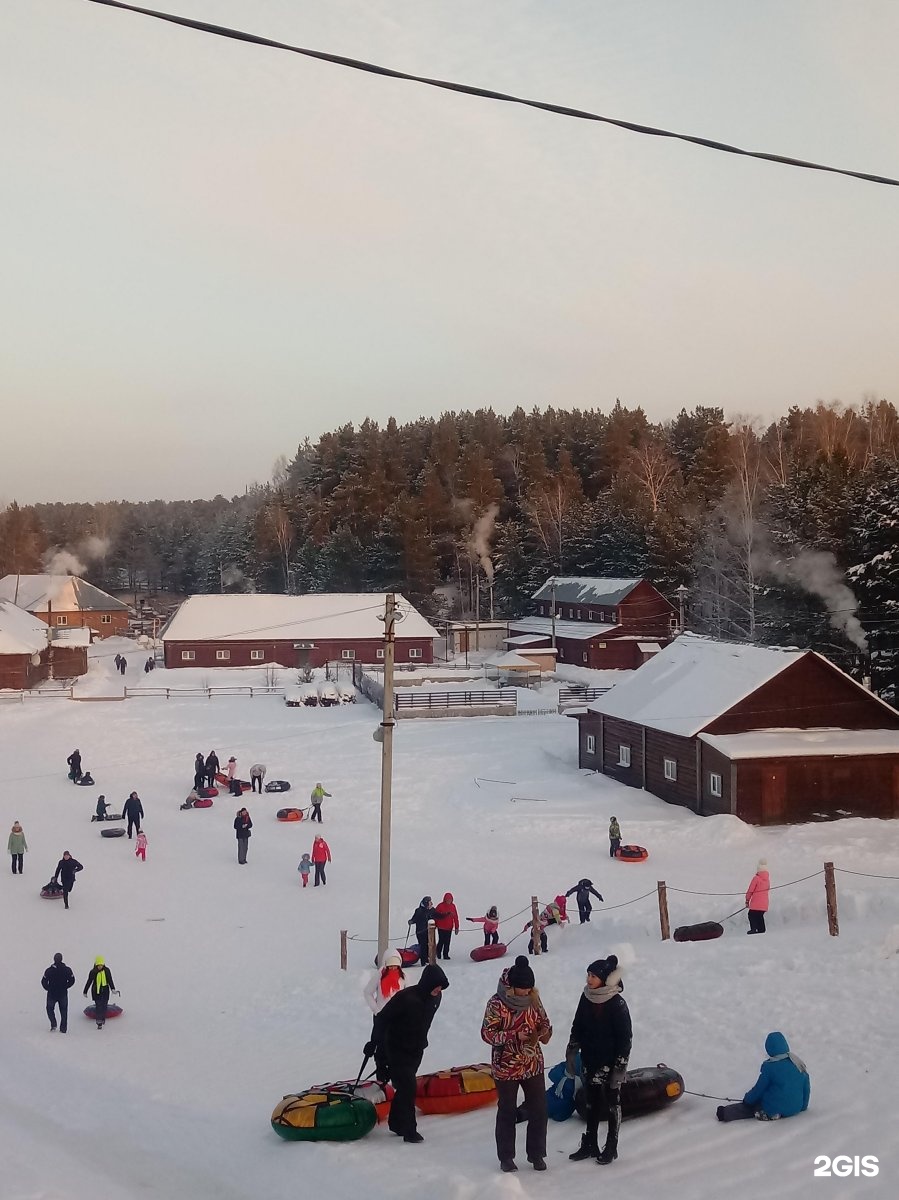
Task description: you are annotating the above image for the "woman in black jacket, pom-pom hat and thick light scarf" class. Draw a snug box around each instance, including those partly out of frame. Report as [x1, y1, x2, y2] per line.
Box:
[565, 954, 633, 1164]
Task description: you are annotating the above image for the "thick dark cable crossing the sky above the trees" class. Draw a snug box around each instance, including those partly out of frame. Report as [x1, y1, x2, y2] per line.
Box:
[82, 0, 899, 187]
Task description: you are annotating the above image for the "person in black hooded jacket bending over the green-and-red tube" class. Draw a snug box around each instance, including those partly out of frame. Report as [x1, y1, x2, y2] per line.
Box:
[365, 966, 449, 1142]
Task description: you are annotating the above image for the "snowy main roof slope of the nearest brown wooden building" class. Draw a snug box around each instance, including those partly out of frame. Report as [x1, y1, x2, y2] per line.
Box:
[589, 634, 811, 738]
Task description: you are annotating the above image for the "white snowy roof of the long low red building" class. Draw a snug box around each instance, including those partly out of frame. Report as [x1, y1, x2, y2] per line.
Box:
[161, 592, 440, 642]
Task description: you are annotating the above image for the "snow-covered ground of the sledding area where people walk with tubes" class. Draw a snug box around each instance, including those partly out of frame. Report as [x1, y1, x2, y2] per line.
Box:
[0, 640, 899, 1200]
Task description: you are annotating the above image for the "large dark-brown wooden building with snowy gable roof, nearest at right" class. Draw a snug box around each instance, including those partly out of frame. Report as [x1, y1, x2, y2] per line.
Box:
[577, 635, 899, 824]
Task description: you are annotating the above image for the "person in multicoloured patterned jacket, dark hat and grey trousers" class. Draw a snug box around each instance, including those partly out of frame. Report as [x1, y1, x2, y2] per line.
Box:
[481, 954, 552, 1171]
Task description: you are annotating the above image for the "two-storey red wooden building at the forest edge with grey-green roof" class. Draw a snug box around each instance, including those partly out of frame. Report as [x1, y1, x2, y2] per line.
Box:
[507, 576, 676, 671]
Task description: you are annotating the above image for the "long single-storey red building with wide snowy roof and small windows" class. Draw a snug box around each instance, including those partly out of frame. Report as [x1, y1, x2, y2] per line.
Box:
[160, 592, 440, 667]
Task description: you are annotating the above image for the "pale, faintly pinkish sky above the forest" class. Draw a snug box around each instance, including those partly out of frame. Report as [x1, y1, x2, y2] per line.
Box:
[0, 0, 899, 504]
